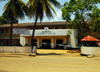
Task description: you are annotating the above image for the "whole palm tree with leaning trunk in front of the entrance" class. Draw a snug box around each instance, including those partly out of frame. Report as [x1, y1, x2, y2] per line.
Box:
[27, 0, 61, 52]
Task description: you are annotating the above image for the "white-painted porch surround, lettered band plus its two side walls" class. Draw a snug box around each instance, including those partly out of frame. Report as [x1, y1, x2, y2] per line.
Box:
[20, 29, 78, 47]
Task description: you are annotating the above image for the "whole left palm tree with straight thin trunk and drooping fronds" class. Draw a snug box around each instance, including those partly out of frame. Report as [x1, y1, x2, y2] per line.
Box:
[3, 0, 27, 46]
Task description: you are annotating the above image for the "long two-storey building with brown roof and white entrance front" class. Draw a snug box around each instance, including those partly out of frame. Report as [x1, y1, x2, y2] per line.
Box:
[0, 22, 98, 48]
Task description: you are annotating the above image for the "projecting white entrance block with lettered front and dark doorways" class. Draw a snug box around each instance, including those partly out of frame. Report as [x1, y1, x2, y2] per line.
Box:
[20, 27, 78, 48]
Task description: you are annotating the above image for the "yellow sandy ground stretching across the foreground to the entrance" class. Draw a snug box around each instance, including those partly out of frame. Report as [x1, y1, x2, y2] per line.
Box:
[0, 49, 100, 72]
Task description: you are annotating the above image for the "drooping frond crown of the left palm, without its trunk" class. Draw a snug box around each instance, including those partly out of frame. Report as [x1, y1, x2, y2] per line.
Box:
[3, 0, 28, 19]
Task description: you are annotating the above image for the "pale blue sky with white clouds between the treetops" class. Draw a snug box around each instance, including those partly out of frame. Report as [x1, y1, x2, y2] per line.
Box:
[0, 0, 69, 23]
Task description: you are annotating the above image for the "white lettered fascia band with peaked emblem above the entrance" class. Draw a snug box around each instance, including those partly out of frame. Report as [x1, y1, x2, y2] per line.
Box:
[30, 27, 72, 36]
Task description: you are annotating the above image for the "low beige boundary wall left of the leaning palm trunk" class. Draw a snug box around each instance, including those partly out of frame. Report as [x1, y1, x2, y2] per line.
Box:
[0, 46, 31, 53]
